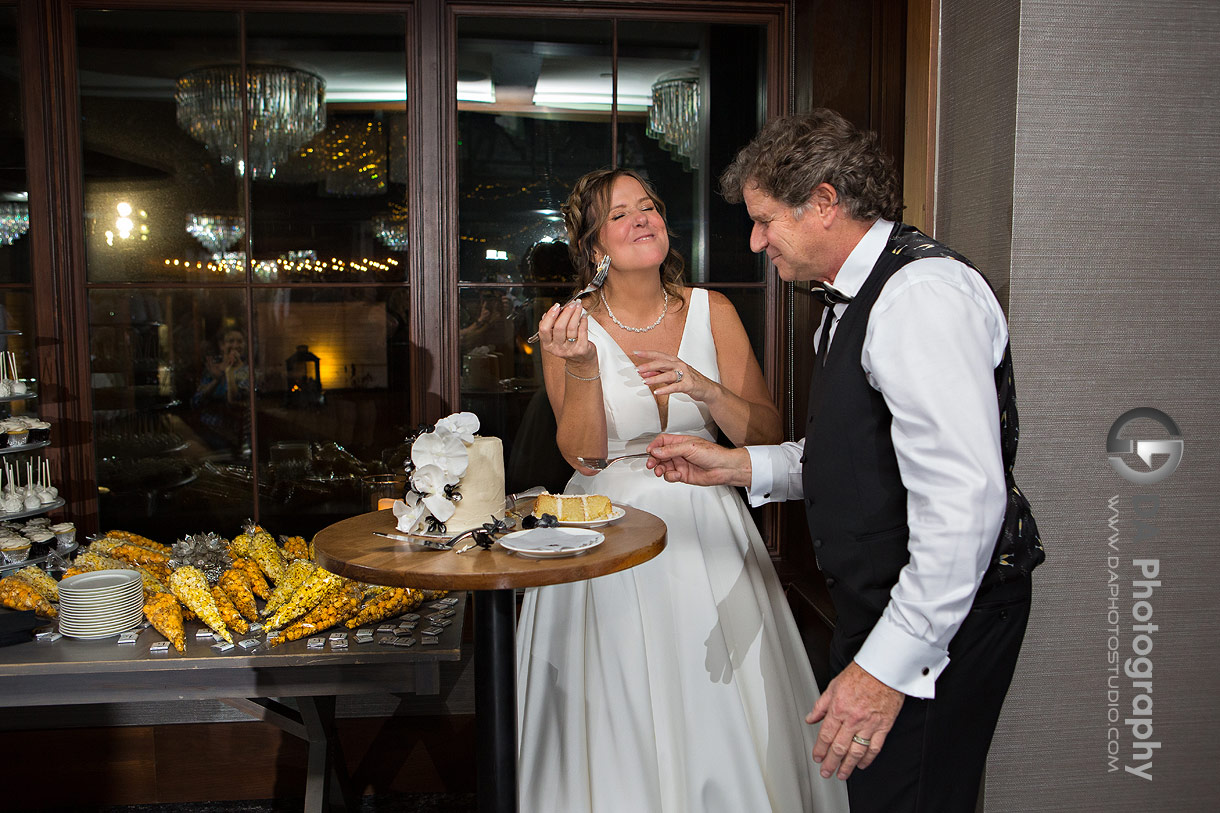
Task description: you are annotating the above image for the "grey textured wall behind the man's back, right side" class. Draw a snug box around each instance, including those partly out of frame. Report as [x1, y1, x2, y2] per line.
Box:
[937, 0, 1220, 813]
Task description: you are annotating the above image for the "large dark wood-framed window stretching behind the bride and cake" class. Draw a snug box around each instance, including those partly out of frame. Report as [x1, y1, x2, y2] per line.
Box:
[7, 0, 788, 540]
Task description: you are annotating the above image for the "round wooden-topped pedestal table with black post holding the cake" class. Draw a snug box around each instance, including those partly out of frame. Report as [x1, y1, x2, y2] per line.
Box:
[314, 507, 666, 812]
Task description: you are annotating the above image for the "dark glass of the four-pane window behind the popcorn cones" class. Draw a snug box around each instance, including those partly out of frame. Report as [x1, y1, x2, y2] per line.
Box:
[76, 10, 410, 541]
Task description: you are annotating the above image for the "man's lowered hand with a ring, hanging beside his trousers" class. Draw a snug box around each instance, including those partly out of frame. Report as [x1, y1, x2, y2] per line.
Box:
[805, 660, 906, 779]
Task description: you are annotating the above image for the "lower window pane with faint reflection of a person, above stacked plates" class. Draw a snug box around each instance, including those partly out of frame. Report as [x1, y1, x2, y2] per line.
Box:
[89, 288, 254, 540]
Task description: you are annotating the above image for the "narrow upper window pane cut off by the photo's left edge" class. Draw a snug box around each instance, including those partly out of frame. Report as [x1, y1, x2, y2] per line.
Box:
[0, 9, 33, 284]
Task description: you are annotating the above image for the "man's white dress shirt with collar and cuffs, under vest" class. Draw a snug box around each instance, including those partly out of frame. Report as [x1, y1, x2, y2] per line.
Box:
[748, 220, 1008, 697]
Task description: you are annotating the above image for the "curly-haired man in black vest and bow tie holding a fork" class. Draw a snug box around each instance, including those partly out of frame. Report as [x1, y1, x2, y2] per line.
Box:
[648, 110, 1043, 813]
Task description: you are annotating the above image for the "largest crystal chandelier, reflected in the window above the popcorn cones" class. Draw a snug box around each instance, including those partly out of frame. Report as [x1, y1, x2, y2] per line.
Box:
[173, 65, 326, 181]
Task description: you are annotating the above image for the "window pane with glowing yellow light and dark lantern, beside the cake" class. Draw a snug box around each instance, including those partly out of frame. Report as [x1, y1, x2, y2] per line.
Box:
[253, 287, 411, 536]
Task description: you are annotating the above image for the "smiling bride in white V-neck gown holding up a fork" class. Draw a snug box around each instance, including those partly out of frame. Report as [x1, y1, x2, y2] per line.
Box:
[517, 170, 847, 813]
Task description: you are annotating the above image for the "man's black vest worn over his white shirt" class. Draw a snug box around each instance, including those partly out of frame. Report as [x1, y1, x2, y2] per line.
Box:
[803, 223, 1046, 670]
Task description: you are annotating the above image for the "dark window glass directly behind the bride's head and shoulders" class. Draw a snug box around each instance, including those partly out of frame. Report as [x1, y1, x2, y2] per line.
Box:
[455, 17, 766, 491]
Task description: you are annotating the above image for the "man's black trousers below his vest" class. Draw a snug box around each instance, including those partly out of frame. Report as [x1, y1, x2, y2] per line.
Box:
[834, 577, 1031, 813]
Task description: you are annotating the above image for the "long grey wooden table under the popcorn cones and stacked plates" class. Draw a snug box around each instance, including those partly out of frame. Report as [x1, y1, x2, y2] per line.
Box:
[0, 597, 466, 813]
